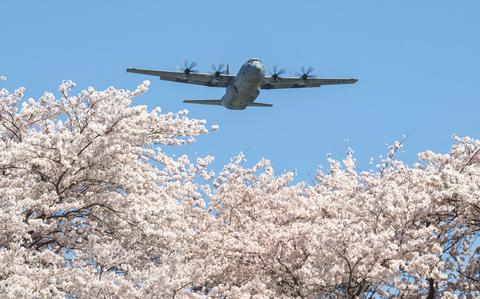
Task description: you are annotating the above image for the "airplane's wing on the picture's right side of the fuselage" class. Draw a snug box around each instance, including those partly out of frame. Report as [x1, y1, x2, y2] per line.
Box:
[260, 77, 357, 89]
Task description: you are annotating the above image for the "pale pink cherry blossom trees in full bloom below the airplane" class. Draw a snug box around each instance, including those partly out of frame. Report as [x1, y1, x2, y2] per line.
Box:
[0, 81, 480, 298]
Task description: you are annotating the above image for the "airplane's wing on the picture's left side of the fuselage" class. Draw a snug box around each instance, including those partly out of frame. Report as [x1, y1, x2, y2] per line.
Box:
[127, 68, 235, 87]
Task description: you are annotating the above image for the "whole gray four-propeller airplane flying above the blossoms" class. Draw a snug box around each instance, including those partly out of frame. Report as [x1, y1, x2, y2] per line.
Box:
[127, 58, 357, 110]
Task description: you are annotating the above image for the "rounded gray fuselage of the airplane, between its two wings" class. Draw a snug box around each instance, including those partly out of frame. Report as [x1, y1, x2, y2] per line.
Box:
[222, 58, 265, 110]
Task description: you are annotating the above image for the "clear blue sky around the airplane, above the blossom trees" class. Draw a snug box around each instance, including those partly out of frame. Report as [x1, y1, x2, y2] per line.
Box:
[0, 0, 480, 179]
